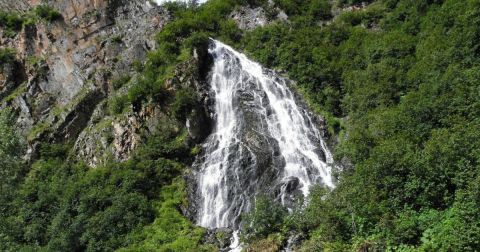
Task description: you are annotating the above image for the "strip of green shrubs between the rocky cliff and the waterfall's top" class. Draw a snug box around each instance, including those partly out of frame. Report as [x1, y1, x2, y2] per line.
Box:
[129, 0, 239, 104]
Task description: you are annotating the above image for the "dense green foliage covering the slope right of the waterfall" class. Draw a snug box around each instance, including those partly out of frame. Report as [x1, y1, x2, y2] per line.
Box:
[242, 0, 480, 251]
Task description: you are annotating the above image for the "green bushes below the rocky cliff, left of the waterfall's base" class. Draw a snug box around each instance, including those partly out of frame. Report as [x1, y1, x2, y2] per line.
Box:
[0, 120, 203, 251]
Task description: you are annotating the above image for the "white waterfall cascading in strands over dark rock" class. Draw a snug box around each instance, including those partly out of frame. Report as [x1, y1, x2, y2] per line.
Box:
[194, 41, 333, 229]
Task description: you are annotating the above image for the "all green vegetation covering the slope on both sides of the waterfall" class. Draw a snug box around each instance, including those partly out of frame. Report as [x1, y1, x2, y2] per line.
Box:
[0, 0, 480, 251]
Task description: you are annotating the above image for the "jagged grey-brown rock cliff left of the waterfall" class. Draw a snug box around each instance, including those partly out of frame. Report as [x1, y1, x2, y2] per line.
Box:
[0, 0, 169, 164]
